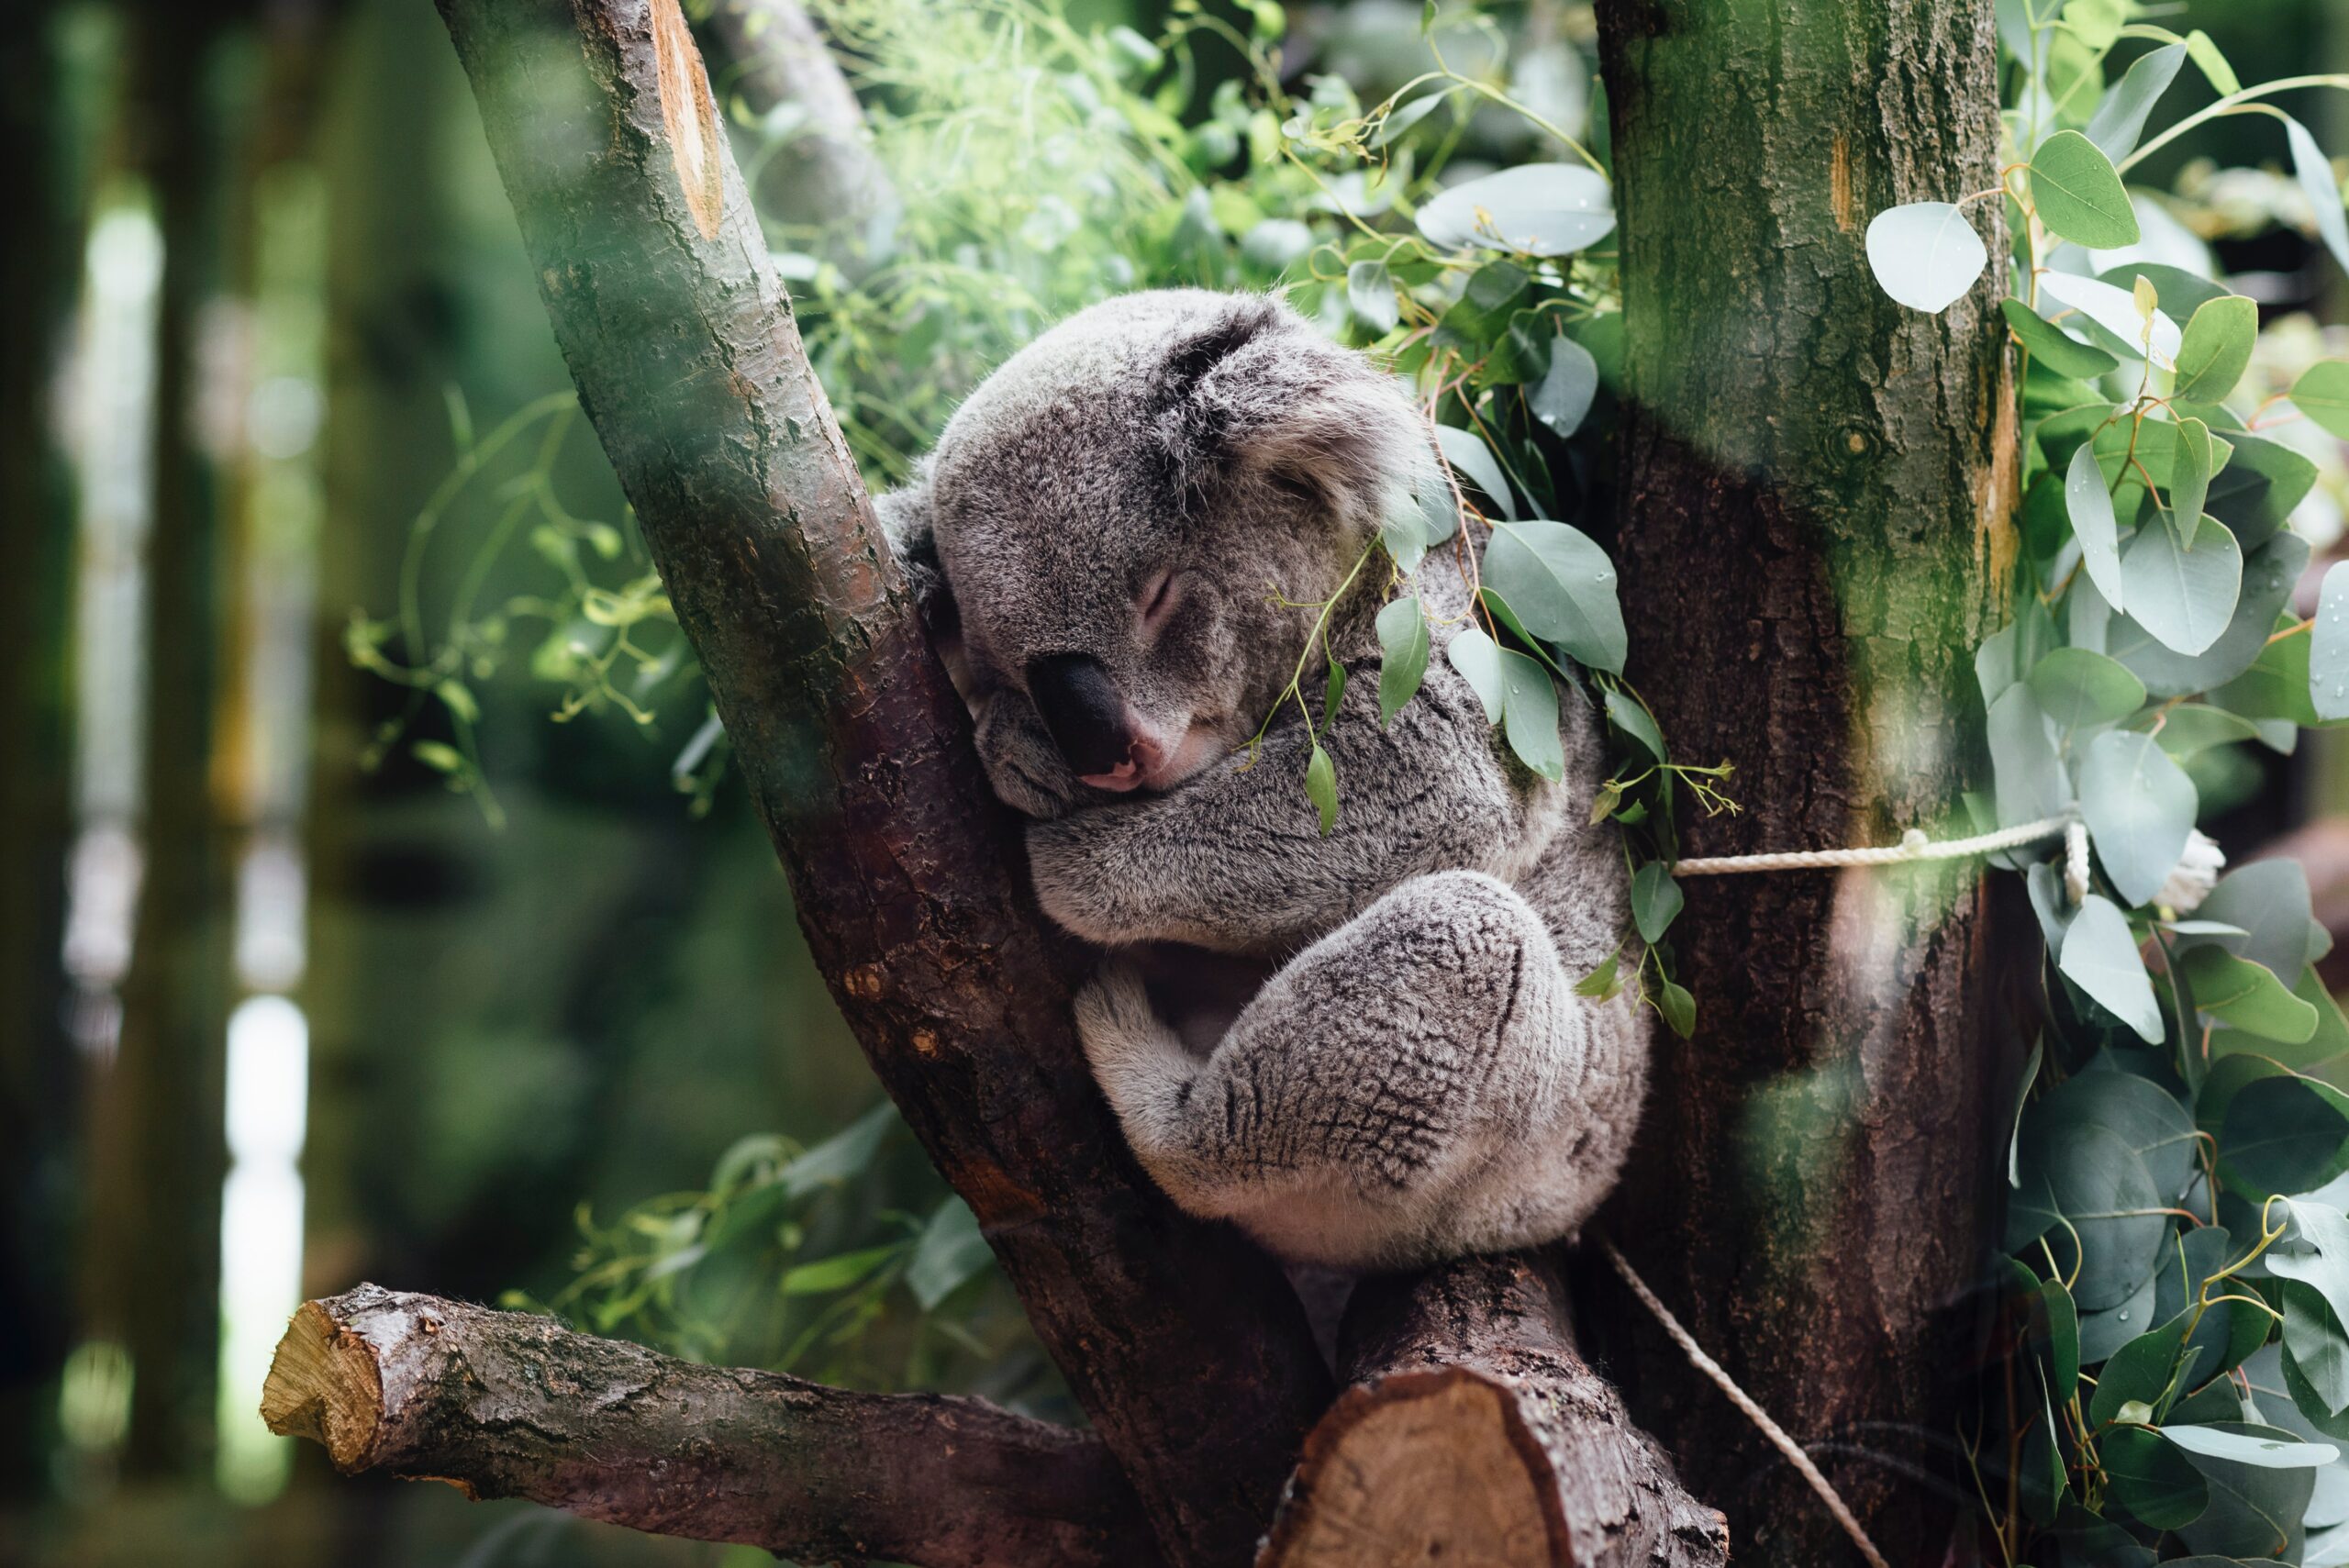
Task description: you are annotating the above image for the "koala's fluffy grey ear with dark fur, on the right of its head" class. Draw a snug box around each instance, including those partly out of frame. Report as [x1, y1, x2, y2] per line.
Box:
[1153, 295, 1431, 530]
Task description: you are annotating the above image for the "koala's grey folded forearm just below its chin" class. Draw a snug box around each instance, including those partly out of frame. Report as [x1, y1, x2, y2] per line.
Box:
[1029, 652, 1541, 953]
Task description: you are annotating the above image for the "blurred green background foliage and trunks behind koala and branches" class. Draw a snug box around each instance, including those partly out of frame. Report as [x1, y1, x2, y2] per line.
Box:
[0, 0, 2349, 1568]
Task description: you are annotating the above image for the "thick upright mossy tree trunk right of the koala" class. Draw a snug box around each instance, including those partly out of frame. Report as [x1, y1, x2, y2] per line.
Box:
[1599, 0, 2015, 1565]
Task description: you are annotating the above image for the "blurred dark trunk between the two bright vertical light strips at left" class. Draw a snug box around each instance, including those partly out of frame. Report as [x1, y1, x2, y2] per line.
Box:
[89, 3, 230, 1476]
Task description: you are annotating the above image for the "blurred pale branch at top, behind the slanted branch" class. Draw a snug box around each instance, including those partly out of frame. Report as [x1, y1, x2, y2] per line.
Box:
[709, 0, 899, 277]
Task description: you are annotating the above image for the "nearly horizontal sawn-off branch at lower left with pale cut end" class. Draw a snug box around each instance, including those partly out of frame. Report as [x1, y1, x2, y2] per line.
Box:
[261, 1284, 1158, 1568]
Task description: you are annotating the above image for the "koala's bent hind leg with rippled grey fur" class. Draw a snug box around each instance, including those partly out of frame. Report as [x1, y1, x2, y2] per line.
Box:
[1075, 871, 1628, 1268]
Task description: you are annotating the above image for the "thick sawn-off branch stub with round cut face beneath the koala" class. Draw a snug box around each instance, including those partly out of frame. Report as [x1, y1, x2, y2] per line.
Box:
[1259, 1253, 1729, 1568]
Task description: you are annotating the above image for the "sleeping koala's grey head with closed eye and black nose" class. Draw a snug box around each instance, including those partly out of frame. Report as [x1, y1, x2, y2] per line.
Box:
[887, 289, 1433, 810]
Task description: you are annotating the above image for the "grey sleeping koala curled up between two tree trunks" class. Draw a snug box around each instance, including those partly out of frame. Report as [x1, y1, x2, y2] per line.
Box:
[881, 289, 1647, 1270]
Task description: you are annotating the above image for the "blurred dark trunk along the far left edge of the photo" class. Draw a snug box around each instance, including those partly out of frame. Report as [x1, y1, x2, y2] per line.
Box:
[0, 3, 83, 1500]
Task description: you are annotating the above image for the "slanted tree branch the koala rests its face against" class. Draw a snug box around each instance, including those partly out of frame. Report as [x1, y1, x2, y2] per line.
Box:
[440, 0, 1330, 1565]
